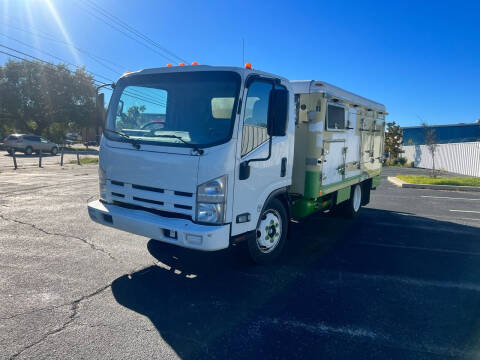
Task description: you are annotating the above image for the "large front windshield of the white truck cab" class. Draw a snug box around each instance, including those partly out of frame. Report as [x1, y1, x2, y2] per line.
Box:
[105, 71, 240, 148]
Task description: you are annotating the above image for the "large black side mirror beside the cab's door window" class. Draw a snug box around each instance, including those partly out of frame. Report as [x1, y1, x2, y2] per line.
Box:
[267, 89, 288, 136]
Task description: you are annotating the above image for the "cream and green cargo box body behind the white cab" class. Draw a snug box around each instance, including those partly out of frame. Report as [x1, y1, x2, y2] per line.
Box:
[291, 81, 386, 216]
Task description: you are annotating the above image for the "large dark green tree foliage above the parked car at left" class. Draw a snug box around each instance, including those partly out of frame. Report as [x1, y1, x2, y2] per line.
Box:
[0, 60, 96, 142]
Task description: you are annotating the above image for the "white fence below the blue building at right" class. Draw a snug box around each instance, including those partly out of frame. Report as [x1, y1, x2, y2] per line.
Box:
[403, 142, 480, 177]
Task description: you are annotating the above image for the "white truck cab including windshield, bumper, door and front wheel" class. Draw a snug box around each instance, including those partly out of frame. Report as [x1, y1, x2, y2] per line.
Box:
[88, 66, 295, 262]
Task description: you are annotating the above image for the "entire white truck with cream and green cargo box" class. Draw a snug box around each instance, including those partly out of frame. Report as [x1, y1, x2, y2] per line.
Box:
[88, 65, 386, 263]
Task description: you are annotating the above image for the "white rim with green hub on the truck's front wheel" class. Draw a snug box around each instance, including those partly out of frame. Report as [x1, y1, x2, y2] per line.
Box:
[257, 209, 282, 254]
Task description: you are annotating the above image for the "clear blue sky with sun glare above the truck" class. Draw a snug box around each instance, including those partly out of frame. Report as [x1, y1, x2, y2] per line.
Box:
[0, 0, 480, 126]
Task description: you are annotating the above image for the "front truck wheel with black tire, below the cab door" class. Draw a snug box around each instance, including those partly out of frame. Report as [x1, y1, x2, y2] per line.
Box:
[248, 198, 288, 265]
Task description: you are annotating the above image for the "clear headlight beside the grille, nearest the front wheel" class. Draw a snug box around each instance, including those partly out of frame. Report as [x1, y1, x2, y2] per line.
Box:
[196, 175, 227, 224]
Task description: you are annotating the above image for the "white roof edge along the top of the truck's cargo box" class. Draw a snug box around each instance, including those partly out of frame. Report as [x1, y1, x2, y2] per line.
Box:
[290, 80, 385, 111]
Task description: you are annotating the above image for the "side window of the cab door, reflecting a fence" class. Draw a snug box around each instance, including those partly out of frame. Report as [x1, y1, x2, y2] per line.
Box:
[242, 81, 273, 155]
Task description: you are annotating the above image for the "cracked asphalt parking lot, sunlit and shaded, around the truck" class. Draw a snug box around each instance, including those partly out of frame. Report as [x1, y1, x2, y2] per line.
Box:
[0, 158, 480, 359]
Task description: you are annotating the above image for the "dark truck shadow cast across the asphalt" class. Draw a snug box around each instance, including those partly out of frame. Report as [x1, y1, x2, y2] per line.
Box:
[112, 208, 480, 359]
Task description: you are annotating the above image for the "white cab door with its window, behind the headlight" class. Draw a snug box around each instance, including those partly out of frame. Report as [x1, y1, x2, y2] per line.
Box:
[232, 78, 291, 235]
